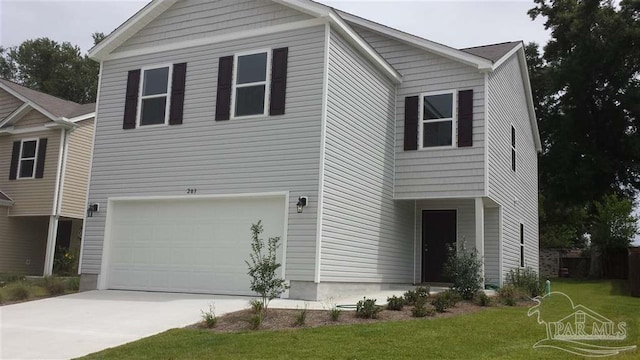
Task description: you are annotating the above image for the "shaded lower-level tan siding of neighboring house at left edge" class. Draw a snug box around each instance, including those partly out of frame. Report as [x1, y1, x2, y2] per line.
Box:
[0, 206, 49, 275]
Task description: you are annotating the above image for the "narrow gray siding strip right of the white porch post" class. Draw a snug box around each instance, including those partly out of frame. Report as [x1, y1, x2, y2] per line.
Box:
[484, 207, 501, 285]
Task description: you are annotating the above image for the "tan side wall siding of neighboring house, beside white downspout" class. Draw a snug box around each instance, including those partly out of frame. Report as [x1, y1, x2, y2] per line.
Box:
[60, 118, 94, 219]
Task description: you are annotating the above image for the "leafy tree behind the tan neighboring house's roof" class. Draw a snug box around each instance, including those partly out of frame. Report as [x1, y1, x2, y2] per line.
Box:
[0, 33, 105, 104]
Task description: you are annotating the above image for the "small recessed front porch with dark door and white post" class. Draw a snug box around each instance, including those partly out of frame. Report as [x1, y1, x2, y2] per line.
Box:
[414, 197, 502, 286]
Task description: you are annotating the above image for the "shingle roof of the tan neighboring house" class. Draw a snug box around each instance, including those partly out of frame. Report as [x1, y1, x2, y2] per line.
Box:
[0, 79, 95, 118]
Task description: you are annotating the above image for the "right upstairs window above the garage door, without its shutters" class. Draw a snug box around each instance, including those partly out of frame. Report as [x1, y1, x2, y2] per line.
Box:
[233, 51, 271, 117]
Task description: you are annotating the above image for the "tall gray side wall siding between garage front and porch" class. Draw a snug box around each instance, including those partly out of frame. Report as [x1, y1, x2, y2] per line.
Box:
[320, 31, 414, 283]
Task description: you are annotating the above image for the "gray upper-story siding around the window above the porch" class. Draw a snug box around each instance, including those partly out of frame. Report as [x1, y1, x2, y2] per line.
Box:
[353, 25, 485, 199]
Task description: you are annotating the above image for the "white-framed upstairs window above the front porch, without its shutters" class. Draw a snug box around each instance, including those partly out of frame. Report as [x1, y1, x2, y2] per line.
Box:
[420, 91, 456, 148]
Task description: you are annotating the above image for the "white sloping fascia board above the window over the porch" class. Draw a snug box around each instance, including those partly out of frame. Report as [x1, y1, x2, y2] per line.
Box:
[340, 11, 493, 71]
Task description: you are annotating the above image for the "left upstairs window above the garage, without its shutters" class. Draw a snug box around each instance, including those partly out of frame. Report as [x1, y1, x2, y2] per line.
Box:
[138, 66, 171, 126]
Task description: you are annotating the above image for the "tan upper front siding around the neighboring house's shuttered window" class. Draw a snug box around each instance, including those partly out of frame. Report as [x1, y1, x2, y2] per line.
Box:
[0, 126, 61, 216]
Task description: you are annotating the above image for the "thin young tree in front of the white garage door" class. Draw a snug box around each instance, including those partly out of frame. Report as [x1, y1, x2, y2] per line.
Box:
[245, 220, 289, 314]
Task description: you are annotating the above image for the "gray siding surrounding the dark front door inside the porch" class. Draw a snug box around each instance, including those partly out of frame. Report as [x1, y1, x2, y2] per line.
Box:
[414, 199, 476, 283]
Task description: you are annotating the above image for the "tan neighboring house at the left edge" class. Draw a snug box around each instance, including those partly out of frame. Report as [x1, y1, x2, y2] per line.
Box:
[0, 79, 95, 275]
